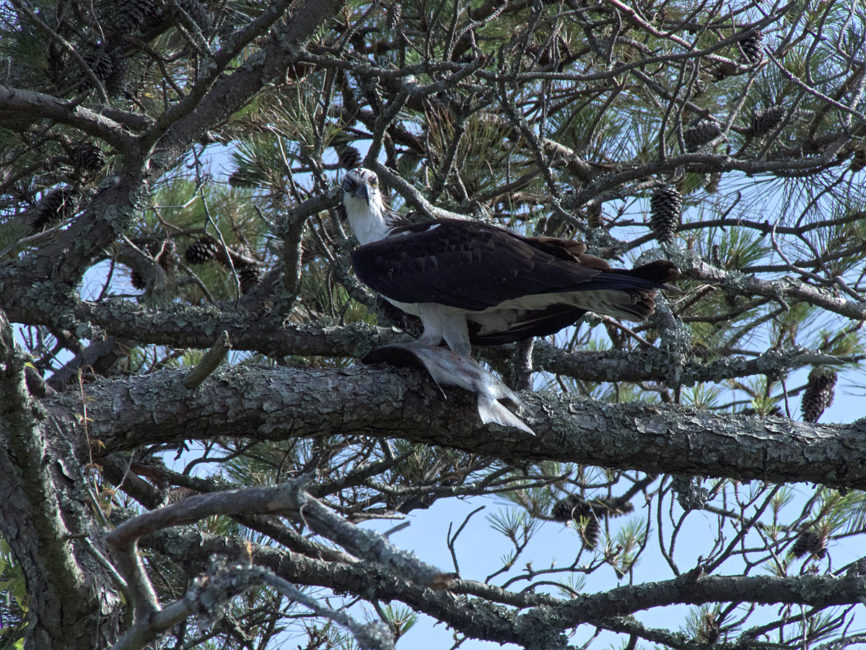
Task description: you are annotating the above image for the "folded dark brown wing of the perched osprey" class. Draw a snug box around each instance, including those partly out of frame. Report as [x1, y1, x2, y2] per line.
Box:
[352, 219, 672, 311]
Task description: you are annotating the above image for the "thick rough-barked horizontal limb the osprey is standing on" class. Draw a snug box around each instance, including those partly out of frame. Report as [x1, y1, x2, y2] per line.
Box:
[43, 367, 866, 489]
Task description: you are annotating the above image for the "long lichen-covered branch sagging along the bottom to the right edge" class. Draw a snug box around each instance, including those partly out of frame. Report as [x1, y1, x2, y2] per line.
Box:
[140, 520, 866, 647]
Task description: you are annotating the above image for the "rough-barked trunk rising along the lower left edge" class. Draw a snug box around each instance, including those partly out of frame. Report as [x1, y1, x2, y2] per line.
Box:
[0, 311, 116, 647]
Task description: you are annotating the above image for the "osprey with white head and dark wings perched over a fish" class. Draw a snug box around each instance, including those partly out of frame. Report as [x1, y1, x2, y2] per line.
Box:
[342, 168, 679, 357]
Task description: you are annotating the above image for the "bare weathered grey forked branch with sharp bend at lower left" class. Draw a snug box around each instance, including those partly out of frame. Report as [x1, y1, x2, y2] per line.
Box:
[106, 475, 456, 650]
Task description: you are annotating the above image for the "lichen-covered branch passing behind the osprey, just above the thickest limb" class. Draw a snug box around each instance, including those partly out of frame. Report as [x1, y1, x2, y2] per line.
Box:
[0, 284, 862, 386]
